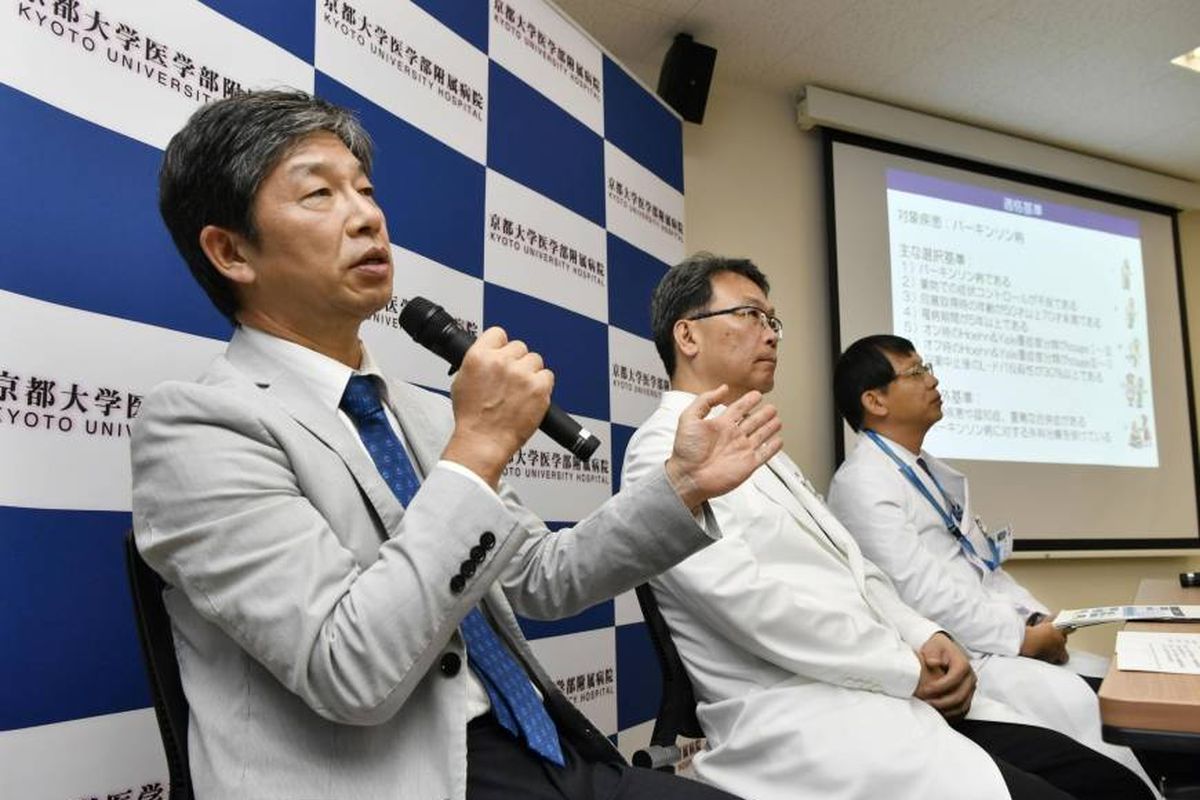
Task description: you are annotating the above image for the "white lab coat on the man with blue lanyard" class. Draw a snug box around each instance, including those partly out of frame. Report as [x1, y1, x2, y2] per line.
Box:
[829, 435, 1150, 783]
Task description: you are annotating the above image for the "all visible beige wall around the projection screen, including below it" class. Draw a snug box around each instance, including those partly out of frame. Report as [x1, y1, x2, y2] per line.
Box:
[686, 72, 1200, 652]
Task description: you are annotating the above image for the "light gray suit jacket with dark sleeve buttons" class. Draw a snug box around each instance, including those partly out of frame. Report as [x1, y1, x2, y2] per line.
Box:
[132, 326, 715, 800]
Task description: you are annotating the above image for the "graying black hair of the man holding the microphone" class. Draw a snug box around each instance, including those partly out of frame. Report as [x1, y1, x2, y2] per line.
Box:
[158, 90, 372, 321]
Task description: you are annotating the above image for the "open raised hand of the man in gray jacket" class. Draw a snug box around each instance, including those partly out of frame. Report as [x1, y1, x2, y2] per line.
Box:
[666, 384, 784, 510]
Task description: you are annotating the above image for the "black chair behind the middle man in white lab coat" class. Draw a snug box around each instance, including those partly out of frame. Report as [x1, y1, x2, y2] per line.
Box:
[634, 583, 704, 772]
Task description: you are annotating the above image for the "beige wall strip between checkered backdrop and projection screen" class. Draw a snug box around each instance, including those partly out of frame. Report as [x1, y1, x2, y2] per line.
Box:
[684, 76, 835, 487]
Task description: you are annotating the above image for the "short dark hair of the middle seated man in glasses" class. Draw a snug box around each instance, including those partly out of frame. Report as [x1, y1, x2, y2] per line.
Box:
[650, 252, 770, 378]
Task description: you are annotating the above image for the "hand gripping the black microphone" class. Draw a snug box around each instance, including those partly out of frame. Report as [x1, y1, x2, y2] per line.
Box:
[442, 327, 554, 487]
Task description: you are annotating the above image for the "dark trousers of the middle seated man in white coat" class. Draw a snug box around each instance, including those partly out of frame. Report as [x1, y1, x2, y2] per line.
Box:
[954, 720, 1153, 800]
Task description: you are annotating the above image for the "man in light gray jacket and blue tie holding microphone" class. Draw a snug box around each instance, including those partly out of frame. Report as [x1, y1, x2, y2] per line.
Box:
[132, 92, 780, 800]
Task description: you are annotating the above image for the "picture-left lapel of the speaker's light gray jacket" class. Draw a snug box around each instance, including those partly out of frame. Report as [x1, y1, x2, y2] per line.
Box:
[226, 335, 404, 531]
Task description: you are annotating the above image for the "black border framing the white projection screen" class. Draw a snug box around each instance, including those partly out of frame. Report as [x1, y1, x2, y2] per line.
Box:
[821, 127, 1200, 554]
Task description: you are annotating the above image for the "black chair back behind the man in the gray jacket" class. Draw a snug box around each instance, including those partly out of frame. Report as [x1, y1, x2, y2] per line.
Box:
[125, 530, 193, 800]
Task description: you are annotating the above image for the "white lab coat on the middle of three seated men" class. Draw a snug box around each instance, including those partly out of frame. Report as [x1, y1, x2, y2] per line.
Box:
[623, 391, 1030, 800]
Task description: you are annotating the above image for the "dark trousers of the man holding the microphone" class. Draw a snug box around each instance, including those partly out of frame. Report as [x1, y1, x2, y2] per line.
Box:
[467, 714, 737, 800]
